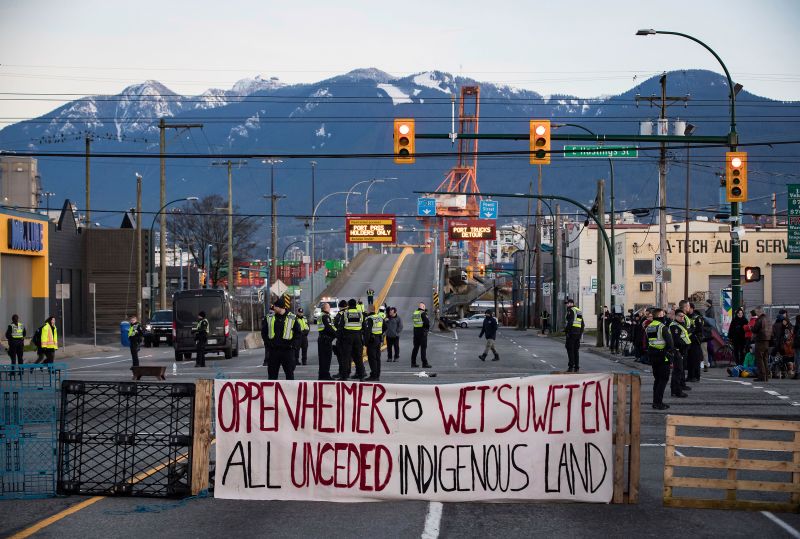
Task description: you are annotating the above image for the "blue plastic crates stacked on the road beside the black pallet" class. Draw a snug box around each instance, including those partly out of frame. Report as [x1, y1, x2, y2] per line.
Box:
[0, 363, 65, 499]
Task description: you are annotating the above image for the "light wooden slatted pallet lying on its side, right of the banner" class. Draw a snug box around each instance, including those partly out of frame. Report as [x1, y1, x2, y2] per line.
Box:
[664, 415, 800, 512]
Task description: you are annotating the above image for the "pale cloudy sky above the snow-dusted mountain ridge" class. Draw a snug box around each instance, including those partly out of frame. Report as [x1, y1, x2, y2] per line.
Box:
[0, 0, 800, 123]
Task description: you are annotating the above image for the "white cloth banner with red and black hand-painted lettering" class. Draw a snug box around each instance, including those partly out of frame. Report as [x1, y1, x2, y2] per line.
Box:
[214, 374, 614, 503]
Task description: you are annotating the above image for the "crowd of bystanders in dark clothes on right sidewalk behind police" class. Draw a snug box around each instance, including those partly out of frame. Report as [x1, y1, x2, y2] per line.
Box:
[601, 301, 800, 379]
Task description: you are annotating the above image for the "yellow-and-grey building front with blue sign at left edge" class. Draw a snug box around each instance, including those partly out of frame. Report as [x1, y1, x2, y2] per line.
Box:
[0, 208, 50, 327]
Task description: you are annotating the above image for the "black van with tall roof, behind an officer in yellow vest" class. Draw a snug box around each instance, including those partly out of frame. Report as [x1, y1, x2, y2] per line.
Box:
[172, 288, 239, 361]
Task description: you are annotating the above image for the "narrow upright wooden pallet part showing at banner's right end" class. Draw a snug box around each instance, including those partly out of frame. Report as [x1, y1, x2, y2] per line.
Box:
[611, 373, 642, 504]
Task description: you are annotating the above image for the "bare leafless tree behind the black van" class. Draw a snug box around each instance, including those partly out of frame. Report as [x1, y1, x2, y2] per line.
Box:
[167, 195, 257, 286]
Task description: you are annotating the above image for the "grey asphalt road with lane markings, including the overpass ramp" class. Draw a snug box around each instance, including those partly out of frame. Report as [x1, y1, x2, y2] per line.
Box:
[0, 255, 800, 538]
